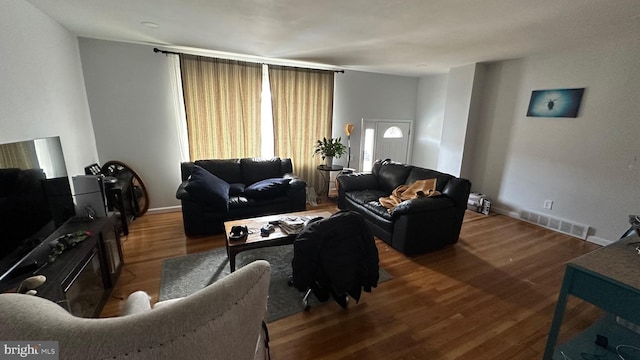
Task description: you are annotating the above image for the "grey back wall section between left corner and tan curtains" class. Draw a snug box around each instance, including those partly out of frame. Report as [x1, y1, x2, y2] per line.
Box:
[78, 38, 181, 214]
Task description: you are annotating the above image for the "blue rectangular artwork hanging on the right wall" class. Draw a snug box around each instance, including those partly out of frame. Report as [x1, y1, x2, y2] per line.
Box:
[527, 88, 584, 117]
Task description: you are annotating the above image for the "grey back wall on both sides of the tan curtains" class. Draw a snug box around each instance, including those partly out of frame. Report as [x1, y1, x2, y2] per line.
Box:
[79, 38, 418, 209]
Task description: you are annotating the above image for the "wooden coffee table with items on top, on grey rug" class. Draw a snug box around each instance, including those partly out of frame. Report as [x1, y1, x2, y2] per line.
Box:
[224, 210, 331, 272]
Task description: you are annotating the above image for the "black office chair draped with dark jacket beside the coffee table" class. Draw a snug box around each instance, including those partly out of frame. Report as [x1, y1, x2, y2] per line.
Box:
[291, 211, 379, 310]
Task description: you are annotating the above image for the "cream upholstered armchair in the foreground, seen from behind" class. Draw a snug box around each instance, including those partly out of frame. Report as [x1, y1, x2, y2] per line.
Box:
[0, 260, 270, 360]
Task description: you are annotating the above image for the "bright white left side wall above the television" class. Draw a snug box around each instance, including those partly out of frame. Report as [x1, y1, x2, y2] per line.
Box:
[0, 1, 98, 176]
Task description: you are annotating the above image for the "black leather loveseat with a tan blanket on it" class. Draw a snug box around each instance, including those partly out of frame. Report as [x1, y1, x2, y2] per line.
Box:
[337, 160, 471, 255]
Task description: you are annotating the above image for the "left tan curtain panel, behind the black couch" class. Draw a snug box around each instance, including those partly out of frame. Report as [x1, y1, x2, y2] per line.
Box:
[180, 54, 262, 161]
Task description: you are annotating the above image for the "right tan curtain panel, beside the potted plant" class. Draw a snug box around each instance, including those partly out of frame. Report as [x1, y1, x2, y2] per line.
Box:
[269, 65, 333, 191]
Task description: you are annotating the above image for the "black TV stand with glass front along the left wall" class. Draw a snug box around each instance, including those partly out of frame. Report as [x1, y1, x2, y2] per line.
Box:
[6, 213, 123, 317]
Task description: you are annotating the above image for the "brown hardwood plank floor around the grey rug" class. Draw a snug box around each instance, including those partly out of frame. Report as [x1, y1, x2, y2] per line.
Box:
[102, 202, 600, 360]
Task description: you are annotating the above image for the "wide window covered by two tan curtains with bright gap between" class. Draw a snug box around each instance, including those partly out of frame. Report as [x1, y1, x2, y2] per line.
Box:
[180, 54, 334, 187]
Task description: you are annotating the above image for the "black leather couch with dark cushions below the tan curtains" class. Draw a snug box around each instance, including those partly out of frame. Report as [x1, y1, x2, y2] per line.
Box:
[176, 158, 307, 236]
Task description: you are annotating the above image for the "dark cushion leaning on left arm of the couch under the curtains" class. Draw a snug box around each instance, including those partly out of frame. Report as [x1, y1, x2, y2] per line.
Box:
[185, 165, 229, 210]
